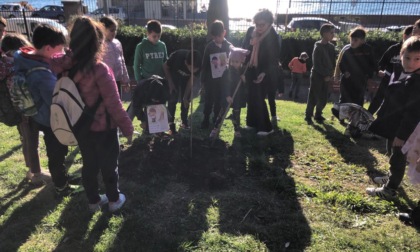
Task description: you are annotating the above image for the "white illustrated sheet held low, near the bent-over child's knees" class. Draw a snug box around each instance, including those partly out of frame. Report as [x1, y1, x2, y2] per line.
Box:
[147, 104, 169, 134]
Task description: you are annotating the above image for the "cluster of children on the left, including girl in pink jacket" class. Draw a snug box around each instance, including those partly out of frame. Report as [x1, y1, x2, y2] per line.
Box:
[0, 17, 133, 212]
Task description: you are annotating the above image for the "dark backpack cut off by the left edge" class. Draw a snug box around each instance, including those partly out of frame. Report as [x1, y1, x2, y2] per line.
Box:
[0, 78, 22, 126]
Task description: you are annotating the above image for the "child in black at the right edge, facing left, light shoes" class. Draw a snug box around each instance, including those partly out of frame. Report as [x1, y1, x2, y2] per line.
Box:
[366, 36, 420, 199]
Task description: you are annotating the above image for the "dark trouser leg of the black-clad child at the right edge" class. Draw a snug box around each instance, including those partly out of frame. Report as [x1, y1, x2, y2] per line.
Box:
[386, 147, 407, 190]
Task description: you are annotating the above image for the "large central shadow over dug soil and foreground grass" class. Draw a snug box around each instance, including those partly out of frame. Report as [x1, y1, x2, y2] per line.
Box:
[83, 125, 311, 251]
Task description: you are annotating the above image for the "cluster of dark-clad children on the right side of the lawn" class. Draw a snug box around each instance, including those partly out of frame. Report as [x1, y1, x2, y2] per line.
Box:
[298, 20, 420, 225]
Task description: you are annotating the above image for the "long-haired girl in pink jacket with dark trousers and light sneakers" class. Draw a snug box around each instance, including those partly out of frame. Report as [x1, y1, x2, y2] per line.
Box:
[52, 17, 134, 212]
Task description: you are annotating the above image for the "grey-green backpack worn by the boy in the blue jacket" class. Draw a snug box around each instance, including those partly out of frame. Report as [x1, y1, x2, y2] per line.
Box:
[10, 67, 51, 116]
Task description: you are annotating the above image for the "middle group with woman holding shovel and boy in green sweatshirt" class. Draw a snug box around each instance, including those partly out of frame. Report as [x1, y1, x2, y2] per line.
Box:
[135, 10, 280, 137]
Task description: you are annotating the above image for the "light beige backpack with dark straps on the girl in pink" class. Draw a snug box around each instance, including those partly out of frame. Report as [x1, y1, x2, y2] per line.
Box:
[50, 73, 102, 145]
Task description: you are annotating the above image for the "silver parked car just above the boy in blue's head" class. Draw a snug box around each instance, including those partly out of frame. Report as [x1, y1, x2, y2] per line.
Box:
[6, 17, 68, 37]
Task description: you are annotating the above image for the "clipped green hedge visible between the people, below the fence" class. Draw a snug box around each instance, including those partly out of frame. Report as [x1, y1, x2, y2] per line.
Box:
[117, 25, 402, 69]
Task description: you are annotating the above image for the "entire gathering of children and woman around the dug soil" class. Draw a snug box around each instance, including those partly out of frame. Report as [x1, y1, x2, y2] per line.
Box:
[0, 10, 420, 222]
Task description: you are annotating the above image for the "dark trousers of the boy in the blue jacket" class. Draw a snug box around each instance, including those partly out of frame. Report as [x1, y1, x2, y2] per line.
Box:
[33, 121, 68, 187]
